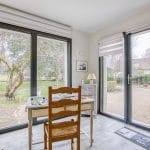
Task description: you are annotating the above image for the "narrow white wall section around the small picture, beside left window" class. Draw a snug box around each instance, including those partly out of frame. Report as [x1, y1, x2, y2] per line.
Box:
[72, 30, 89, 86]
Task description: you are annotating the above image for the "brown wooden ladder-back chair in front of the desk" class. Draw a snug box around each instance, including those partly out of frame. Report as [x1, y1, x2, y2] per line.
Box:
[44, 86, 81, 150]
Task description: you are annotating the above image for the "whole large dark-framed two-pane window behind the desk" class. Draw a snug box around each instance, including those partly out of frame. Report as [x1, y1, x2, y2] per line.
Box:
[0, 23, 71, 133]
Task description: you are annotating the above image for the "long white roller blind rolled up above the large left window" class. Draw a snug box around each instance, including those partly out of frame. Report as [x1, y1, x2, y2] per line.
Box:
[0, 4, 72, 38]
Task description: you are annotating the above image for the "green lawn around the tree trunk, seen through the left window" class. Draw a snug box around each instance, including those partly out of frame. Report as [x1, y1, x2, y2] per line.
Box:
[0, 80, 64, 108]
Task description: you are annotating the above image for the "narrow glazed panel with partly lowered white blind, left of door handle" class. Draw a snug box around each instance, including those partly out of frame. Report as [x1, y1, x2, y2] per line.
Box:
[99, 37, 124, 118]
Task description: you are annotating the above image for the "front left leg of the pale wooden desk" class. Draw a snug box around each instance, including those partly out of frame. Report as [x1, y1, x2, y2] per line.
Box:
[28, 109, 32, 150]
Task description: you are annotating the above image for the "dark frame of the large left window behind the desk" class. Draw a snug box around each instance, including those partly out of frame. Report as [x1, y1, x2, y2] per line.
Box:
[0, 22, 72, 134]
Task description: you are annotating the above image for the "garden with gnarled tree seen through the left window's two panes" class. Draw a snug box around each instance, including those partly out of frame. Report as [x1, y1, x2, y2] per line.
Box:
[0, 29, 67, 128]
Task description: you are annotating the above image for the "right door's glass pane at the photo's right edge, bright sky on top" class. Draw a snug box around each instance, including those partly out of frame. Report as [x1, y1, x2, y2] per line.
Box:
[131, 29, 150, 125]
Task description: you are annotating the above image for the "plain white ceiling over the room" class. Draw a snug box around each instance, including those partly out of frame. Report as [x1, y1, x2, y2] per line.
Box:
[0, 0, 150, 33]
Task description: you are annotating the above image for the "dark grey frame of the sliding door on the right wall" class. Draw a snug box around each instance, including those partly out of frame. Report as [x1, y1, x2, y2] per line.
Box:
[97, 29, 150, 131]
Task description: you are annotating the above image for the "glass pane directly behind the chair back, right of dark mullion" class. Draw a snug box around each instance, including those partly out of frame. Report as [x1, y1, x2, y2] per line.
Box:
[37, 36, 67, 97]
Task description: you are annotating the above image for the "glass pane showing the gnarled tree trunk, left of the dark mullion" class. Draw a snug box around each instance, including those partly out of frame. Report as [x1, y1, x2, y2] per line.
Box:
[0, 29, 31, 129]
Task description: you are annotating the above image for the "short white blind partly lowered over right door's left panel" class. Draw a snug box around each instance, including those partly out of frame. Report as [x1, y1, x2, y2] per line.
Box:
[99, 35, 124, 56]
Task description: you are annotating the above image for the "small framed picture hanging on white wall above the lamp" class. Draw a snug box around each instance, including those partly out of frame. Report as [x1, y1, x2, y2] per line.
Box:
[76, 60, 88, 72]
